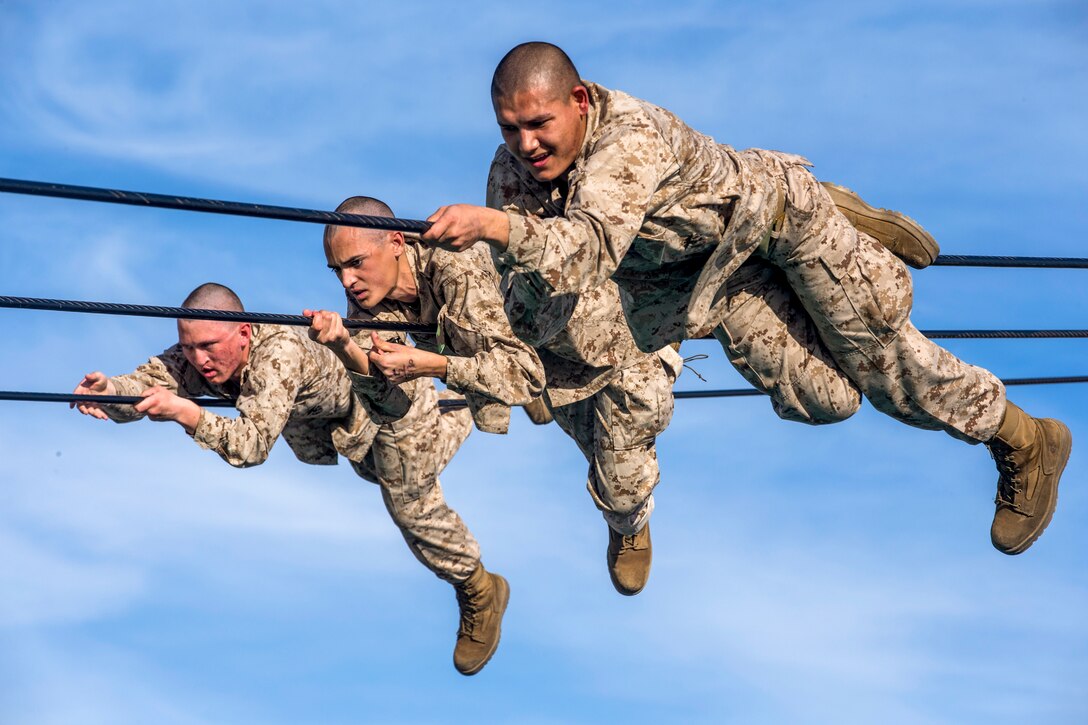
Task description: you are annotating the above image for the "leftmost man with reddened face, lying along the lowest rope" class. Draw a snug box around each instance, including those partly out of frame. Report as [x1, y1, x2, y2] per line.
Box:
[66, 283, 482, 666]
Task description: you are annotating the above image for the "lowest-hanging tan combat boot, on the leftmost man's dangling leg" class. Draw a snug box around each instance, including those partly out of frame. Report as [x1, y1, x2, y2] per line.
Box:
[454, 564, 510, 675]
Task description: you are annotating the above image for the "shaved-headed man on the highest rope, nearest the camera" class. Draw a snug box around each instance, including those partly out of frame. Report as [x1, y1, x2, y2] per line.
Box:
[423, 42, 1072, 554]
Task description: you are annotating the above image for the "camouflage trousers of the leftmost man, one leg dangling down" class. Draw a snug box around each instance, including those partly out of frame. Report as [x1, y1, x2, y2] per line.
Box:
[351, 382, 480, 583]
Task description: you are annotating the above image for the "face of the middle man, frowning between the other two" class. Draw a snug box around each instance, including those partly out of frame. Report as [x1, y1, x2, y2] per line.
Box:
[325, 226, 401, 309]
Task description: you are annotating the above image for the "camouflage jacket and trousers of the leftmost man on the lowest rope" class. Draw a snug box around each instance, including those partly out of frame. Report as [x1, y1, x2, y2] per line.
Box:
[102, 324, 480, 581]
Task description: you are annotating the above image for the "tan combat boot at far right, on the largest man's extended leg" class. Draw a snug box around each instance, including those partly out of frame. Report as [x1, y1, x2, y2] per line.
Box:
[986, 403, 1073, 554]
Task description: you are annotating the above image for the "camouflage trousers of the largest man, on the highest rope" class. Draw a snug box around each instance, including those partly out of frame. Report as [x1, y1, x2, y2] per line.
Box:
[714, 164, 1005, 443]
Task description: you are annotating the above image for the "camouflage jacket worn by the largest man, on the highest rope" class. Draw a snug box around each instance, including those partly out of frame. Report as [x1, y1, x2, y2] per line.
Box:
[491, 82, 808, 351]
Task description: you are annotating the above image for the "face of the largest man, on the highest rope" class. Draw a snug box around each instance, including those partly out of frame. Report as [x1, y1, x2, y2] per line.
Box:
[492, 85, 590, 182]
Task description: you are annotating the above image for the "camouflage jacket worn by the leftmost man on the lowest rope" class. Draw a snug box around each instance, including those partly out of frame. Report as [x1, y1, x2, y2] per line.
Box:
[102, 324, 378, 467]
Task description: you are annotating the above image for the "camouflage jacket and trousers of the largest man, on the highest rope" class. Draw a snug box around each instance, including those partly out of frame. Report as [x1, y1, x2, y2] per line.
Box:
[493, 78, 1005, 442]
